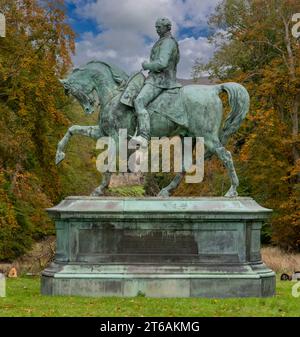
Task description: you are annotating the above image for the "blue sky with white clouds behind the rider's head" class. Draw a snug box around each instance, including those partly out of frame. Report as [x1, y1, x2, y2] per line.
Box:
[65, 0, 220, 79]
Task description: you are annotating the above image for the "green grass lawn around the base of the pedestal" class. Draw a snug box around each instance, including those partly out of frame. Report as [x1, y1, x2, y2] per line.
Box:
[0, 277, 300, 317]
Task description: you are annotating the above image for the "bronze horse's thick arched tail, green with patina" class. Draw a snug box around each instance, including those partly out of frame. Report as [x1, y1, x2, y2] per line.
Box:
[218, 82, 250, 145]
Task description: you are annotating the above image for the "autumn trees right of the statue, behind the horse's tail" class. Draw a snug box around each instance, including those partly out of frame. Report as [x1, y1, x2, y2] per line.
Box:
[194, 0, 300, 249]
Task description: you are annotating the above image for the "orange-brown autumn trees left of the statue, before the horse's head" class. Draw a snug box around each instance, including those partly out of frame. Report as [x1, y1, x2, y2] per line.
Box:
[0, 0, 74, 260]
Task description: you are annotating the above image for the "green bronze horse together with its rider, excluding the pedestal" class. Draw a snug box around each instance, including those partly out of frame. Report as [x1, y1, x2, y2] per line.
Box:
[56, 18, 250, 197]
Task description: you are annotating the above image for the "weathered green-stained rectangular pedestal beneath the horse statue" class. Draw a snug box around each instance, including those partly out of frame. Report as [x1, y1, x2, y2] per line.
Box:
[42, 197, 275, 297]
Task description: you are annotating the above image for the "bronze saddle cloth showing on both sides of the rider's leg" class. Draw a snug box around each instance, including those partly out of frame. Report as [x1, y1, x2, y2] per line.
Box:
[120, 71, 188, 127]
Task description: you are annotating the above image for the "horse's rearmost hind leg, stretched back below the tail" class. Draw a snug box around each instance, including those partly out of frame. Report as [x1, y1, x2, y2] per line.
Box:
[205, 141, 239, 198]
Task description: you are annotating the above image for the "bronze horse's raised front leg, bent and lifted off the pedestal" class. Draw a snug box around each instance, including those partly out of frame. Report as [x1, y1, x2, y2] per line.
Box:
[55, 125, 101, 165]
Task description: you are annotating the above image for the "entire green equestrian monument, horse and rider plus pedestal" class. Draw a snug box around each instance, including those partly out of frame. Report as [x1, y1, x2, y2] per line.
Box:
[49, 18, 275, 297]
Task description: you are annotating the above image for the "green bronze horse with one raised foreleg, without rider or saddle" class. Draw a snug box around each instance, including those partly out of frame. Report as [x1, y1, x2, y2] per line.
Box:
[56, 61, 250, 197]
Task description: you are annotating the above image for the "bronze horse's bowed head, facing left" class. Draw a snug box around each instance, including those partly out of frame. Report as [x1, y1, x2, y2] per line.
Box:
[60, 69, 97, 115]
